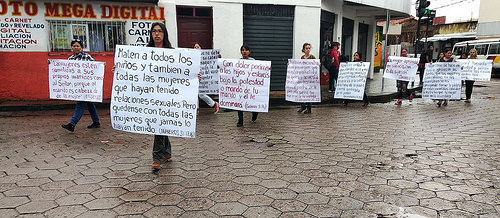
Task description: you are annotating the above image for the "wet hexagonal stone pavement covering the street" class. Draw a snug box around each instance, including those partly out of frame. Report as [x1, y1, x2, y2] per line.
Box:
[0, 80, 500, 218]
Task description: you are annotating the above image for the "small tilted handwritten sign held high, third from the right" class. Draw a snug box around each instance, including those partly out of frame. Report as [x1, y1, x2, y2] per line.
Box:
[384, 56, 418, 81]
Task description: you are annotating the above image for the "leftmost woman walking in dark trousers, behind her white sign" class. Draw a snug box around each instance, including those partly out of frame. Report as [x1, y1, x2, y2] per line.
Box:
[61, 39, 101, 132]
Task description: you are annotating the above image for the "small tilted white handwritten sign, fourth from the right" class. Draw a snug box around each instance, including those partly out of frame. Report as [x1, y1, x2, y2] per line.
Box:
[334, 62, 370, 100]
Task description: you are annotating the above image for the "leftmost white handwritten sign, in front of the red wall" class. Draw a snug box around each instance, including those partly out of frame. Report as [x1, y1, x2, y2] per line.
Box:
[49, 60, 104, 102]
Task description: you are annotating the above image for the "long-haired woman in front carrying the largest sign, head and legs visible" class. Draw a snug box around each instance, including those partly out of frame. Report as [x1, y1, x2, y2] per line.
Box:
[146, 22, 172, 170]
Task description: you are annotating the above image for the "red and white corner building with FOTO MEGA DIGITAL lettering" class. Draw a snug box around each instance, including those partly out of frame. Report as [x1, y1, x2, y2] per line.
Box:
[0, 0, 411, 100]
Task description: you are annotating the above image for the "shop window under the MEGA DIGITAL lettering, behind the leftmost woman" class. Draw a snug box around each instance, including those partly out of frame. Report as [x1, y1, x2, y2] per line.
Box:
[49, 20, 125, 52]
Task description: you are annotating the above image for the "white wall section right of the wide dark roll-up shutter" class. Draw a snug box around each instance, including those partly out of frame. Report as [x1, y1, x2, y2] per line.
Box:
[293, 6, 321, 59]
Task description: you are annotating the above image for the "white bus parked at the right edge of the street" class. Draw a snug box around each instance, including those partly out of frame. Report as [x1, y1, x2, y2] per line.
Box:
[453, 38, 500, 73]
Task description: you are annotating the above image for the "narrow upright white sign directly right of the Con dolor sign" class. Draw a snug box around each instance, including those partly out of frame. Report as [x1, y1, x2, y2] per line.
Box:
[285, 59, 321, 102]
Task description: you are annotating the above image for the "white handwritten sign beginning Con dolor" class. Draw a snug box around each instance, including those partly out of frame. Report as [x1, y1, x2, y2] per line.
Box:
[219, 59, 271, 112]
